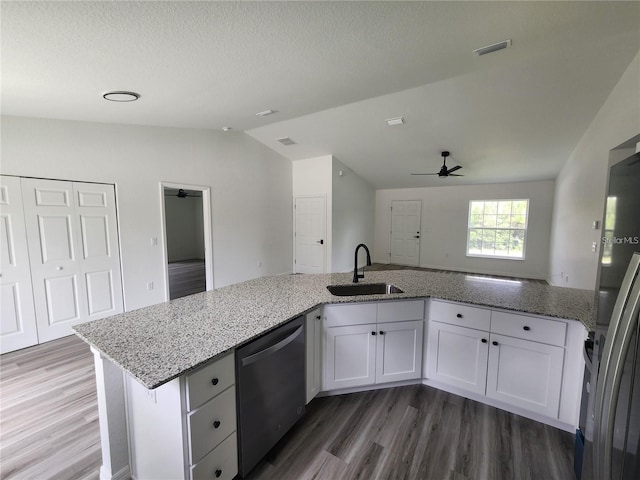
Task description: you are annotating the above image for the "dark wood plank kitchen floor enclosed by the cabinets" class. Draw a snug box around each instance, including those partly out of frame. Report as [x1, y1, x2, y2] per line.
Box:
[247, 385, 574, 480]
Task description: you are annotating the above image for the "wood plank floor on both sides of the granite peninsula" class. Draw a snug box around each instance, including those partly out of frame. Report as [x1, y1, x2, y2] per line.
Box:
[0, 336, 574, 480]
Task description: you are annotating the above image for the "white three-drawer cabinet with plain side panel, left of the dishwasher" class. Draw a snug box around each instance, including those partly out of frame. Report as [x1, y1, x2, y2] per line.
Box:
[125, 354, 238, 480]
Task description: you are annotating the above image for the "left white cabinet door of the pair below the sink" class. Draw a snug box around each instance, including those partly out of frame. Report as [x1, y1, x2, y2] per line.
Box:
[322, 323, 378, 390]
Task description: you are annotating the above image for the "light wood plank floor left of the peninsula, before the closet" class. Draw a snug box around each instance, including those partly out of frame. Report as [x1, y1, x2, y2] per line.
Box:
[0, 335, 102, 480]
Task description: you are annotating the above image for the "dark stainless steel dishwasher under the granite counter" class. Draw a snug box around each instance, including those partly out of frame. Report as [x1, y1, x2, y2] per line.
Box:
[236, 317, 305, 477]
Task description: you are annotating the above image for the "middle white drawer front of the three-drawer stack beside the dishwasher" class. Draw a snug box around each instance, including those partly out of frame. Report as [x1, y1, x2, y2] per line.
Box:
[187, 387, 236, 465]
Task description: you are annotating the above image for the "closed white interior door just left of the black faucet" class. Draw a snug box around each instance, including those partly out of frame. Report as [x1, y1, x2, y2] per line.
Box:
[294, 196, 327, 273]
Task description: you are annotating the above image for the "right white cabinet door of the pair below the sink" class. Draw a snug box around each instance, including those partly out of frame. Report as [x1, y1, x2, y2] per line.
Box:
[376, 320, 424, 383]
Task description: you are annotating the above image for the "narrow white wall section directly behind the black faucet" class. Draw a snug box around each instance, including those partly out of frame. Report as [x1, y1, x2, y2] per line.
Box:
[331, 158, 375, 272]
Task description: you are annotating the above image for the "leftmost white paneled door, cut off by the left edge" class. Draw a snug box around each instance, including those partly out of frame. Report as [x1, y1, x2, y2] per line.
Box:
[0, 176, 38, 353]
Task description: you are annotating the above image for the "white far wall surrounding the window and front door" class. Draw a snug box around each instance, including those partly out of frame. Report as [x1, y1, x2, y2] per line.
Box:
[374, 180, 554, 279]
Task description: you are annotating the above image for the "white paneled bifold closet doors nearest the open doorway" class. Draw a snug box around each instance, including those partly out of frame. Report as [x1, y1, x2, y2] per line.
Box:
[22, 178, 123, 342]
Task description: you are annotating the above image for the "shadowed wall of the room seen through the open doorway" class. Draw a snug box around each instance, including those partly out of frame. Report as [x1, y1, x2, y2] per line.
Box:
[164, 194, 204, 262]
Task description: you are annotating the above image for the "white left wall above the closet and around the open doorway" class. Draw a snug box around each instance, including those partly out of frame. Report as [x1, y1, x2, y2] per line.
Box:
[1, 117, 293, 310]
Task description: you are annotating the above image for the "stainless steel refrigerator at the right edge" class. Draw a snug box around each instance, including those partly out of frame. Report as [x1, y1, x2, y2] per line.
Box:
[578, 153, 640, 480]
